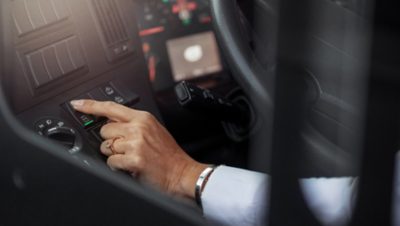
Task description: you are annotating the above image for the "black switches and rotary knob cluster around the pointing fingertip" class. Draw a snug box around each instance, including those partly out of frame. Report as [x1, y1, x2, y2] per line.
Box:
[28, 81, 140, 160]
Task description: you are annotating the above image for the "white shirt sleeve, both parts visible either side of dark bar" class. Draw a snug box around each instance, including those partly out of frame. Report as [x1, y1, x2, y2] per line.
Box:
[201, 166, 357, 226]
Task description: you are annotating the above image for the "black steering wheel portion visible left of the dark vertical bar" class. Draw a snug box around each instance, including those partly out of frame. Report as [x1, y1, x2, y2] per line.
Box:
[210, 0, 276, 172]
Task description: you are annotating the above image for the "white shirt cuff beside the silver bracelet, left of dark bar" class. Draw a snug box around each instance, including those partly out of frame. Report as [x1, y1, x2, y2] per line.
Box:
[201, 166, 269, 226]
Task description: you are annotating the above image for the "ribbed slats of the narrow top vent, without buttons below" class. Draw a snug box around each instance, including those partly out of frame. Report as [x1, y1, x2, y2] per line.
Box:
[92, 0, 128, 47]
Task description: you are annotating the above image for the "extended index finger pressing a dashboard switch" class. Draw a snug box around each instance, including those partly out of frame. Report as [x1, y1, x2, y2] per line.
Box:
[70, 100, 136, 122]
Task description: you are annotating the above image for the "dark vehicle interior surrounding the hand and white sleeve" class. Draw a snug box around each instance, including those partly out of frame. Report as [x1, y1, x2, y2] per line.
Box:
[0, 0, 400, 225]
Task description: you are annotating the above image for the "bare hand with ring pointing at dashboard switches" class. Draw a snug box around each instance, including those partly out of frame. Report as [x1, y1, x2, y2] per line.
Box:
[71, 100, 207, 198]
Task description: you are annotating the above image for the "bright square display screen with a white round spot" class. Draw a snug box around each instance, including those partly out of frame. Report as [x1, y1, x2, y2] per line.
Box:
[167, 32, 222, 81]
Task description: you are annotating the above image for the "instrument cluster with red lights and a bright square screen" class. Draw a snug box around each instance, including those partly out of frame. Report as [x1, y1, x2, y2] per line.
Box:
[136, 0, 223, 91]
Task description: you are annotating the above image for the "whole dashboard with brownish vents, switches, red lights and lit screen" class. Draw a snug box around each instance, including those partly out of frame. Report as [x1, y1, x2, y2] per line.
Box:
[2, 0, 239, 165]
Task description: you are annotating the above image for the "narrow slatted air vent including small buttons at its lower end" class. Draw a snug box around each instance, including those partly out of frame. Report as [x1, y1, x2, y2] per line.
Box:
[92, 0, 134, 61]
